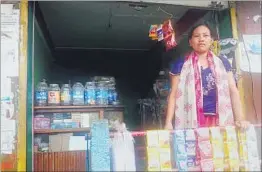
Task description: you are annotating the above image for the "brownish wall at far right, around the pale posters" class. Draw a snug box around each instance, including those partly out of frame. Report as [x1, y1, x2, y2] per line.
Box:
[237, 1, 261, 123]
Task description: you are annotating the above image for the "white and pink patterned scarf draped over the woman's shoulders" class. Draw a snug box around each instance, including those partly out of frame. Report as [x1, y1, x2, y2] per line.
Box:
[174, 51, 234, 129]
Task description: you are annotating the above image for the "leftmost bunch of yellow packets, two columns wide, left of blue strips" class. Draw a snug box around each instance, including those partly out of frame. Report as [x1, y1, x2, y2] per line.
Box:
[147, 131, 172, 171]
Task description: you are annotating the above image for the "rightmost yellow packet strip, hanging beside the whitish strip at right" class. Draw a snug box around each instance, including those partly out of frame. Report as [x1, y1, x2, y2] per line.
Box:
[224, 126, 240, 171]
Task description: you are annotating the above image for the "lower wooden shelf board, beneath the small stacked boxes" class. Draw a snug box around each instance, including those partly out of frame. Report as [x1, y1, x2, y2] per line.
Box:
[34, 128, 90, 134]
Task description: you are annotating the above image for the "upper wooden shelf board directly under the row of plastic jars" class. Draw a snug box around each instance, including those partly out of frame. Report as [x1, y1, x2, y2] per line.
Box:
[34, 105, 124, 114]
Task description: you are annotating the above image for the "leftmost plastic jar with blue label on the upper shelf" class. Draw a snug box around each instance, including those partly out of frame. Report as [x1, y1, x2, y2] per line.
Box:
[35, 79, 48, 106]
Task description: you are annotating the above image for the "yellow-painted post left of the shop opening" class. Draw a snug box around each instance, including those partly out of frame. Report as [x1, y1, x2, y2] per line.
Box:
[17, 0, 28, 171]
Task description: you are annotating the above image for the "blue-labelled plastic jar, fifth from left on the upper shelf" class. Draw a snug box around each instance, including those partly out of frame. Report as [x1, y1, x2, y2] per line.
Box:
[85, 82, 96, 105]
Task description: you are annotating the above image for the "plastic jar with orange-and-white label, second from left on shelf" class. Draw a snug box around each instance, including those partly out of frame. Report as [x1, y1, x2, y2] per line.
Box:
[48, 84, 60, 106]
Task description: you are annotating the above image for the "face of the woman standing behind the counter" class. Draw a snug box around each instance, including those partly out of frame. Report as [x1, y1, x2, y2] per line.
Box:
[189, 26, 213, 54]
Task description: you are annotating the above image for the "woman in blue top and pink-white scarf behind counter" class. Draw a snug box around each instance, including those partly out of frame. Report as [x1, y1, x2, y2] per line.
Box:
[165, 24, 248, 130]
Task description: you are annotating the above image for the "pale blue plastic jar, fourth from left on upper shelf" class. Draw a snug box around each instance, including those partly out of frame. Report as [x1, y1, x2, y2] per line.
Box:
[73, 82, 85, 105]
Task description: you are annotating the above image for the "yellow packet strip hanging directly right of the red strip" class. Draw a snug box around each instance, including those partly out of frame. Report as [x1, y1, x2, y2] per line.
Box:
[210, 127, 224, 171]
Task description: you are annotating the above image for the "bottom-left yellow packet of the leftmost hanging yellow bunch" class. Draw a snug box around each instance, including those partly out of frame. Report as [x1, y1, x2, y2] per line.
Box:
[147, 147, 160, 171]
